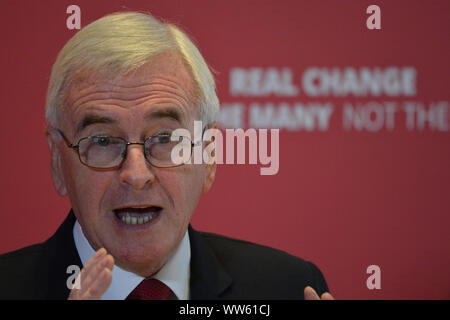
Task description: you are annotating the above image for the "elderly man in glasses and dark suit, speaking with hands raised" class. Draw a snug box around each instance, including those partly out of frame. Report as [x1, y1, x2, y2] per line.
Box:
[0, 12, 331, 299]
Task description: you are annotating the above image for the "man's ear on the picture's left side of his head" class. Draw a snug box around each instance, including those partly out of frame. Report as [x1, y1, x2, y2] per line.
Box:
[45, 127, 67, 197]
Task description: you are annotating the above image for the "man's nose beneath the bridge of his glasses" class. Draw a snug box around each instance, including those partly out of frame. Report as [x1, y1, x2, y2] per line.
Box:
[119, 145, 155, 190]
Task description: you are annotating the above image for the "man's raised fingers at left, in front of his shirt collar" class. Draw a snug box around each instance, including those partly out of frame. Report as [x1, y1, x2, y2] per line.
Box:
[69, 248, 114, 300]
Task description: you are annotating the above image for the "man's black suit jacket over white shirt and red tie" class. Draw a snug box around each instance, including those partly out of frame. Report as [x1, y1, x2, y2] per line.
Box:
[0, 211, 328, 300]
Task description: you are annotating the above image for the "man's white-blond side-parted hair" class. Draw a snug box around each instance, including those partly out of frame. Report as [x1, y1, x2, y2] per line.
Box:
[45, 12, 219, 127]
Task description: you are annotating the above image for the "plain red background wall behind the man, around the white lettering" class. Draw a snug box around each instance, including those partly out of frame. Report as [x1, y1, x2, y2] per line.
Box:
[0, 0, 450, 299]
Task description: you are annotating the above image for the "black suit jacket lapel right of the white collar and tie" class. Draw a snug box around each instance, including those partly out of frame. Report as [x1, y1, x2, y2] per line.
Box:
[189, 225, 232, 300]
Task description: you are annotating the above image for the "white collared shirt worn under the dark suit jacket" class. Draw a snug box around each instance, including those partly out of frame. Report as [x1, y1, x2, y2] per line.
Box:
[73, 220, 191, 300]
